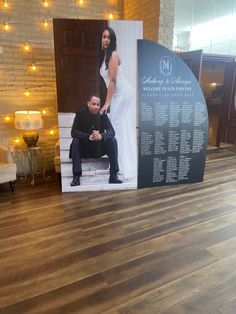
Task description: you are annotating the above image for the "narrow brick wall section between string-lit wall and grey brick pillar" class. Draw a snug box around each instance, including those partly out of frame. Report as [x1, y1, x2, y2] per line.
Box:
[124, 0, 160, 42]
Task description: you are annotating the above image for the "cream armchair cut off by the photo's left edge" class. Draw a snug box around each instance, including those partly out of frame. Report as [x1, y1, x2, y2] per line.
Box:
[0, 145, 16, 192]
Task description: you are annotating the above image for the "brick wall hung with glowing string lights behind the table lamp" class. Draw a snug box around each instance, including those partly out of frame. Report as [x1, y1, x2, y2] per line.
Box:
[0, 0, 123, 170]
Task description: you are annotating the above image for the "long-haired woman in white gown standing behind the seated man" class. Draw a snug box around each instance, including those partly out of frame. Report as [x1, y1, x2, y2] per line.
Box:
[100, 27, 137, 179]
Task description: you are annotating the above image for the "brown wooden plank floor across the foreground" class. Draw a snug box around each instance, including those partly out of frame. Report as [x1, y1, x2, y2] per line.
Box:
[0, 149, 236, 314]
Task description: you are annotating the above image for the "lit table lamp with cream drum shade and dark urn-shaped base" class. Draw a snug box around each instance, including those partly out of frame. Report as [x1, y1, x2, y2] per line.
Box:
[15, 111, 43, 147]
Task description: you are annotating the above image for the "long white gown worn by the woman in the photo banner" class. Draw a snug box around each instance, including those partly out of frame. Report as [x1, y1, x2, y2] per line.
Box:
[100, 62, 137, 179]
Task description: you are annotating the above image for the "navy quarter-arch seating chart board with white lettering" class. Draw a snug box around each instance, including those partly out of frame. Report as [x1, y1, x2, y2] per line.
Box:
[138, 40, 208, 188]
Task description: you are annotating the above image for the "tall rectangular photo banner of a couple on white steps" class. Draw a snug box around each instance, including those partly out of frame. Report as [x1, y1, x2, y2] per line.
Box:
[53, 19, 143, 192]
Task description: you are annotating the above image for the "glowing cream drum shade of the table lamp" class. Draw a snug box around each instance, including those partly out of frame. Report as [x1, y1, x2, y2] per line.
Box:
[15, 111, 43, 130]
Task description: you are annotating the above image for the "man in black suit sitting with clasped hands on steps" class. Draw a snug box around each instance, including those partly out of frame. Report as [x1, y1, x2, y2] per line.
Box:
[70, 96, 123, 186]
